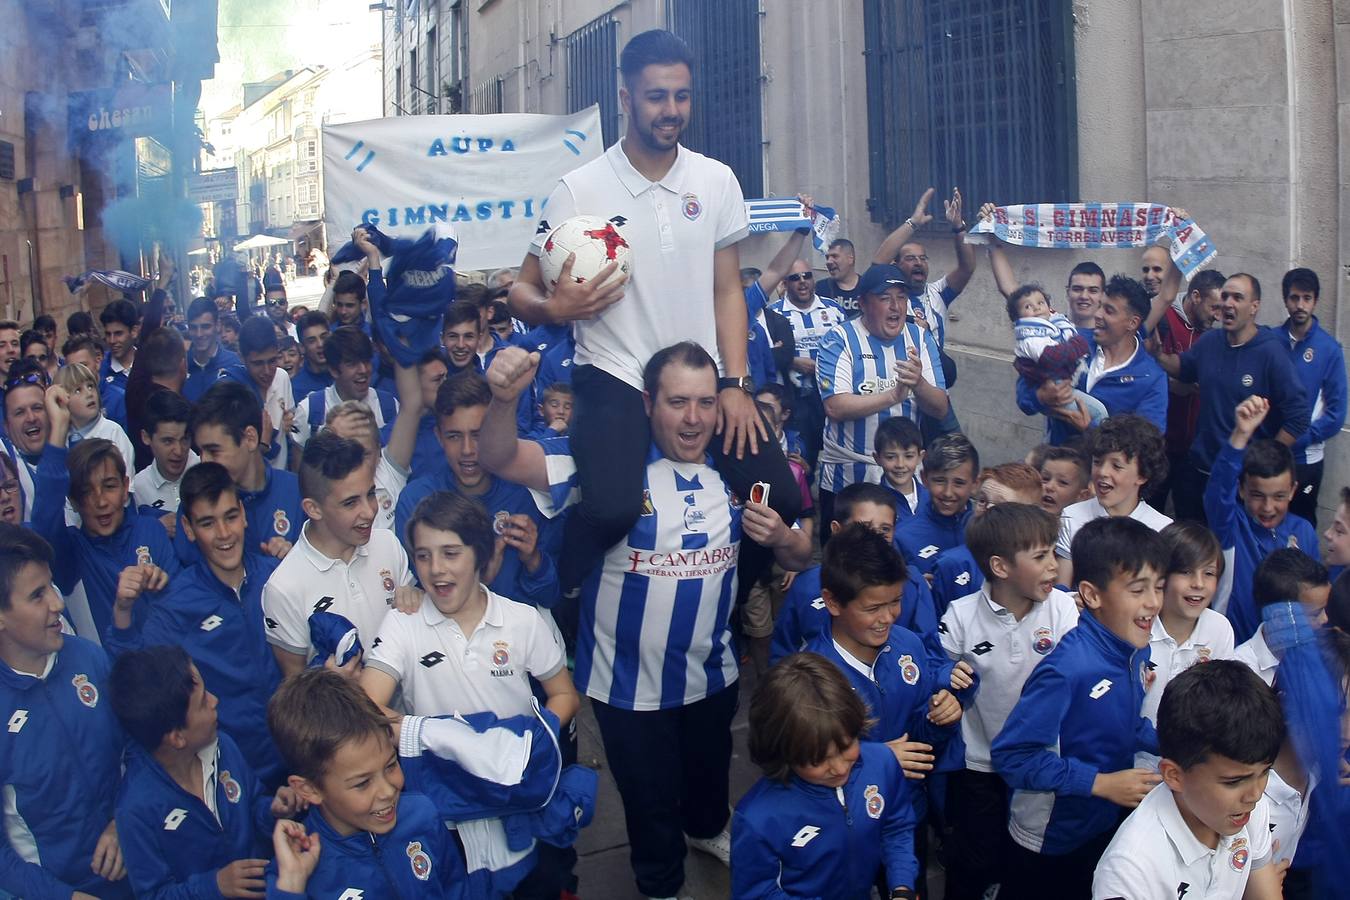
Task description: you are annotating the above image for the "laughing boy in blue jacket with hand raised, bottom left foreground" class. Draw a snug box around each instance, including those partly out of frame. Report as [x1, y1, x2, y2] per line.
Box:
[266, 668, 466, 900]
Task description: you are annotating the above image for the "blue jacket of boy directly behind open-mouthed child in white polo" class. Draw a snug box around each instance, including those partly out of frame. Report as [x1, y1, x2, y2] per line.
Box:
[394, 469, 562, 610]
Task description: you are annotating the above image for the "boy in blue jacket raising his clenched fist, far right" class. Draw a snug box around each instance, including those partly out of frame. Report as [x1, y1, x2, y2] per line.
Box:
[1204, 397, 1319, 644]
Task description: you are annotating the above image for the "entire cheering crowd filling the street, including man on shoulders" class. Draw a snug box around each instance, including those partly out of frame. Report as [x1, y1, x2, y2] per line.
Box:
[0, 24, 1350, 900]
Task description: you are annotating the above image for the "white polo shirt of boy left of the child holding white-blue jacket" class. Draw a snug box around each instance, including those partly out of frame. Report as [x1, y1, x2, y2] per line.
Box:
[262, 522, 412, 660]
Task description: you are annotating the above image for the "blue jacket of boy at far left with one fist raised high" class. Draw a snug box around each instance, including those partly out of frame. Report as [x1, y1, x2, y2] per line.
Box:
[32, 445, 180, 641]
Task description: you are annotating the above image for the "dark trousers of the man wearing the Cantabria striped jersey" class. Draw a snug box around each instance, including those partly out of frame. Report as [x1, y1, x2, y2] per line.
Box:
[593, 684, 740, 897]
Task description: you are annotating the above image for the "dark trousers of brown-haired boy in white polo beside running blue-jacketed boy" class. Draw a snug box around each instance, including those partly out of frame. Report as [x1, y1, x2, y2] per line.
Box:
[944, 769, 1013, 900]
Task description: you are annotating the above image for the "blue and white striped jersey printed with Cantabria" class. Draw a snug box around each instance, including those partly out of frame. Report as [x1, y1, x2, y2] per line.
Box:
[536, 437, 741, 711]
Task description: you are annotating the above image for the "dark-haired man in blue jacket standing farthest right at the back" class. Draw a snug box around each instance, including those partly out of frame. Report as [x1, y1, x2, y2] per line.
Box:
[1280, 269, 1346, 524]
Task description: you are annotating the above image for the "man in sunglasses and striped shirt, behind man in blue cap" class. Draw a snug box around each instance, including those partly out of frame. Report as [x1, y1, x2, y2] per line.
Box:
[770, 259, 848, 468]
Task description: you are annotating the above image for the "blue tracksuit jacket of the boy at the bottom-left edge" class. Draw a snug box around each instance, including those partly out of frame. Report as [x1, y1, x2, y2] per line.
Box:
[0, 637, 131, 900]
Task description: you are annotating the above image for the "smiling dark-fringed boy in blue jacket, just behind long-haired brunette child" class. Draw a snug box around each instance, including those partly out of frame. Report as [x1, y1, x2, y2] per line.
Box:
[807, 525, 971, 884]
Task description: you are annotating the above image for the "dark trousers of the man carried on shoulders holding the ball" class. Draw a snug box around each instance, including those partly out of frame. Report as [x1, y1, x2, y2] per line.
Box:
[558, 366, 802, 591]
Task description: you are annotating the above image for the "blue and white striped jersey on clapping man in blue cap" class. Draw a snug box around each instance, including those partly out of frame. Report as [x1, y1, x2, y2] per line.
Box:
[815, 318, 946, 493]
